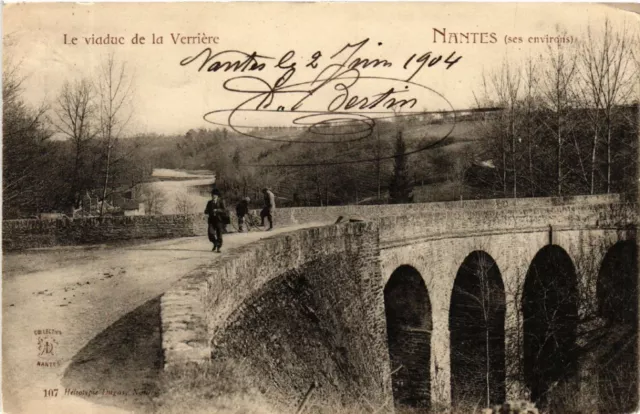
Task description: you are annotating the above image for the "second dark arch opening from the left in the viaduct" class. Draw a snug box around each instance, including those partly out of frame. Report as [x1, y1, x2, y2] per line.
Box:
[449, 250, 505, 411]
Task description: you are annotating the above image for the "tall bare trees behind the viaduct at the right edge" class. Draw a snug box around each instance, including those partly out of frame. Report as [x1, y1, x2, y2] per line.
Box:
[476, 20, 640, 197]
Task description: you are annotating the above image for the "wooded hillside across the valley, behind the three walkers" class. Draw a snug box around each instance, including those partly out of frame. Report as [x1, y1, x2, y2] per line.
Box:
[140, 119, 488, 205]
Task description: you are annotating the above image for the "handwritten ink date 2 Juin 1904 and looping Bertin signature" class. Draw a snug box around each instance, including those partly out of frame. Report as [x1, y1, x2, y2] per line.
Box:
[180, 38, 462, 163]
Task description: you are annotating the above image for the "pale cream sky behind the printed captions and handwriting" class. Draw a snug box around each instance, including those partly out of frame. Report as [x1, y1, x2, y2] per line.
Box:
[3, 3, 639, 134]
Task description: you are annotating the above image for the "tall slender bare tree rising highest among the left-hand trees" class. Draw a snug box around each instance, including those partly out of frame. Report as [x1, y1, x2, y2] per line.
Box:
[52, 79, 98, 208]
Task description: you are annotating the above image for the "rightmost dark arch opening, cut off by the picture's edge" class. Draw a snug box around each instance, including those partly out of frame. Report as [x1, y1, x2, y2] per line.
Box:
[595, 240, 638, 412]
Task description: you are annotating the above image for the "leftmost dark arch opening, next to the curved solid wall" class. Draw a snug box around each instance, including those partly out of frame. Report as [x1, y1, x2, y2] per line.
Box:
[384, 265, 432, 410]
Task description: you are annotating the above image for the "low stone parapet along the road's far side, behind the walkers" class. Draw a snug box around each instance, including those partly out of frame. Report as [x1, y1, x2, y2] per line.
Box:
[2, 194, 621, 251]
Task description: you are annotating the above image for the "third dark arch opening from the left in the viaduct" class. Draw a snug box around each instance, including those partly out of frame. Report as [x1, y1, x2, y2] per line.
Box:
[522, 245, 578, 407]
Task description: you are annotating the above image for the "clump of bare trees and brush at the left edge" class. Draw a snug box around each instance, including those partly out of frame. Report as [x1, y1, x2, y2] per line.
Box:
[2, 55, 152, 218]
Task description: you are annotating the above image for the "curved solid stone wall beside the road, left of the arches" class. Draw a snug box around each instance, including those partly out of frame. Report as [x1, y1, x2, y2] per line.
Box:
[162, 223, 391, 411]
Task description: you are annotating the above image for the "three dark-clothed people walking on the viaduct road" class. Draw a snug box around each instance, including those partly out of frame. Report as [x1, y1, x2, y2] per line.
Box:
[204, 188, 276, 253]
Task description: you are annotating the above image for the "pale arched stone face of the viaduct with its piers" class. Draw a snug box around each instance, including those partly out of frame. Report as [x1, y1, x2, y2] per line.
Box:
[380, 204, 637, 406]
